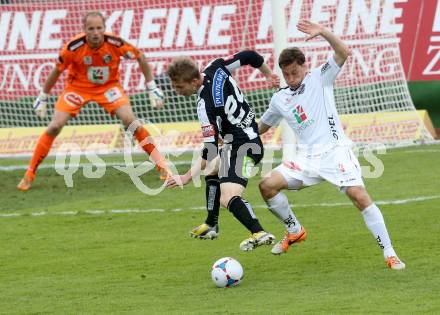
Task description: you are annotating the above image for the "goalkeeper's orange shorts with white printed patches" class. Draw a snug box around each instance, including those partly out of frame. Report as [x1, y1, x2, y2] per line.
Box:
[55, 84, 130, 117]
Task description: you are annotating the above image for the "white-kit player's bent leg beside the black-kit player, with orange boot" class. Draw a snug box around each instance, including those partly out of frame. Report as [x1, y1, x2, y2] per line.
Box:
[259, 165, 307, 255]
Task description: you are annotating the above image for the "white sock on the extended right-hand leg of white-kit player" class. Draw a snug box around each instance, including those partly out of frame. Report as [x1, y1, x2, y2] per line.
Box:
[361, 203, 397, 258]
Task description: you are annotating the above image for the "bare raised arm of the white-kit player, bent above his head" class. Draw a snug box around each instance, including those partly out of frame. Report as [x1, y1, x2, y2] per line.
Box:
[296, 20, 350, 66]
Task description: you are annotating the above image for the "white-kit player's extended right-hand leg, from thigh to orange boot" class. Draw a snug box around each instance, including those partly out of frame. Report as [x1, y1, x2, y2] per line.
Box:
[345, 186, 405, 270]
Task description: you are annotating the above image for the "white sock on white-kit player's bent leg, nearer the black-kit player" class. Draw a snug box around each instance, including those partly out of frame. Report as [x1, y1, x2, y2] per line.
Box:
[266, 192, 301, 233]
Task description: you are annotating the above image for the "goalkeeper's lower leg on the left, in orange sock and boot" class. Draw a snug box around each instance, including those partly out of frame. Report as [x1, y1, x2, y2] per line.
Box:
[17, 109, 71, 191]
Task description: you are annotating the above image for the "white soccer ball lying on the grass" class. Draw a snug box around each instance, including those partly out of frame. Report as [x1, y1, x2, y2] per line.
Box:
[211, 257, 243, 288]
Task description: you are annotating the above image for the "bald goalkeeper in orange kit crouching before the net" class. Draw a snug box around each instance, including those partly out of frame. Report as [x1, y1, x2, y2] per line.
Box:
[17, 12, 169, 190]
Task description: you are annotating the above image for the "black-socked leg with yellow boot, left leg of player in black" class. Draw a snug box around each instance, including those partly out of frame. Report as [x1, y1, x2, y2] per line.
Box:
[190, 158, 220, 239]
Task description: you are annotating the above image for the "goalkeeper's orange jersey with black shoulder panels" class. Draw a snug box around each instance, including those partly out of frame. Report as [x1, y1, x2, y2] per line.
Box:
[56, 33, 141, 93]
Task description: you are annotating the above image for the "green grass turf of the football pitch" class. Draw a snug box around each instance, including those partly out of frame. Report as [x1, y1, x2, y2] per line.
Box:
[0, 145, 440, 315]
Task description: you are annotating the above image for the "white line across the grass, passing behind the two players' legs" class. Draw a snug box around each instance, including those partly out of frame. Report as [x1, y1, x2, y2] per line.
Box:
[0, 195, 440, 218]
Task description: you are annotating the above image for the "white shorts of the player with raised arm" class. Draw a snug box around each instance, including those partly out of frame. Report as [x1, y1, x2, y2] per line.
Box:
[274, 147, 364, 191]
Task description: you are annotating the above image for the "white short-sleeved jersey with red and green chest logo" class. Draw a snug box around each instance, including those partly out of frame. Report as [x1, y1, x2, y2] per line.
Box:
[261, 56, 351, 152]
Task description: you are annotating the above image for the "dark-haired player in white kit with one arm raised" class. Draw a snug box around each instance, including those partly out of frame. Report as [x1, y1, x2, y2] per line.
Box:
[258, 21, 405, 270]
